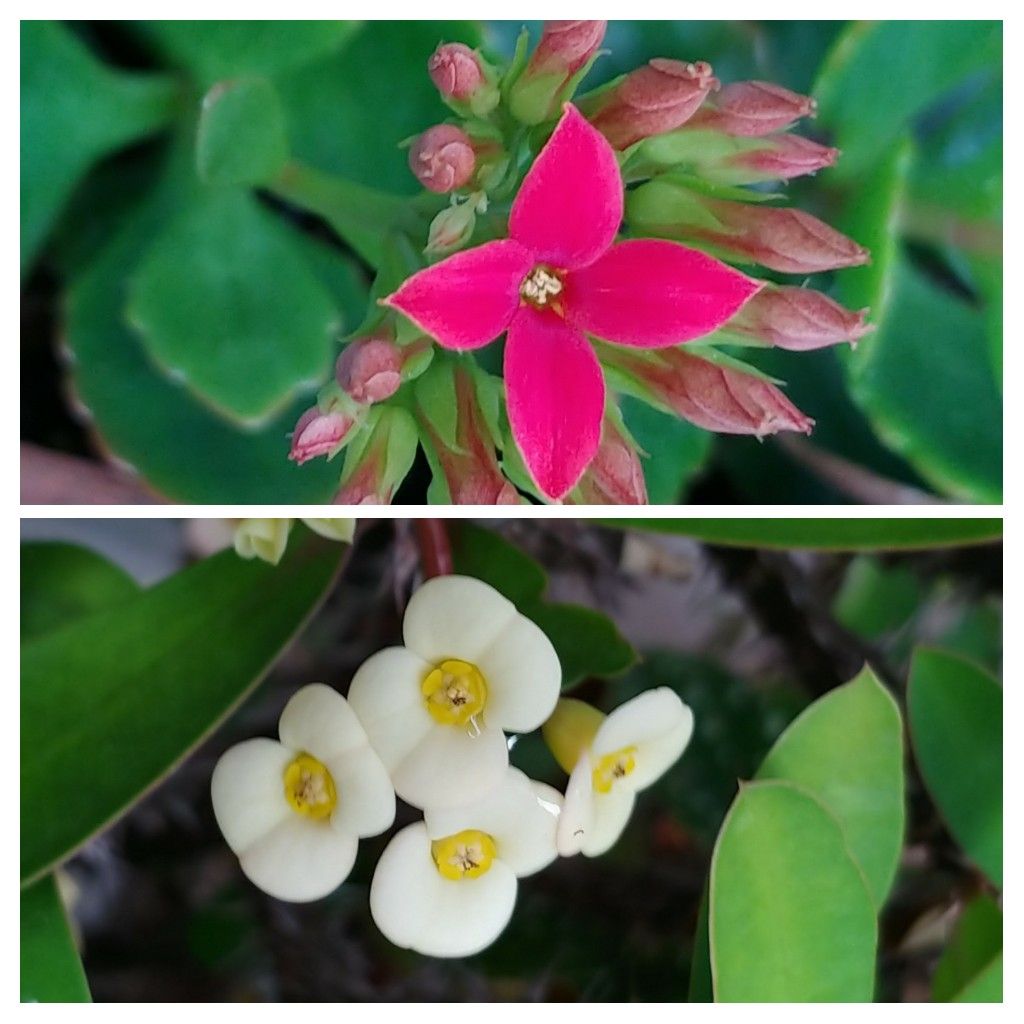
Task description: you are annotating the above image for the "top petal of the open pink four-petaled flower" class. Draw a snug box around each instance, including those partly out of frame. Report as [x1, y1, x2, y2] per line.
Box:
[509, 104, 623, 269]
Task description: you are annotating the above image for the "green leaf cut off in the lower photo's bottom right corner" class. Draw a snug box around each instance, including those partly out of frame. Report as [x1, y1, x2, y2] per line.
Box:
[932, 896, 1002, 1002]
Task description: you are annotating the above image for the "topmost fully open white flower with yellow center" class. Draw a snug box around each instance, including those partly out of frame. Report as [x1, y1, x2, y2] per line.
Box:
[348, 575, 561, 808]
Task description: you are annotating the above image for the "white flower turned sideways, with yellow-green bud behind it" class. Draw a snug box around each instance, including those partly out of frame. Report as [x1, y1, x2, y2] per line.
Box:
[544, 686, 693, 857]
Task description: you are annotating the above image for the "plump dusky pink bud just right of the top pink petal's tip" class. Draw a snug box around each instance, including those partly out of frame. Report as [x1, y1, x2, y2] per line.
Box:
[584, 58, 718, 150]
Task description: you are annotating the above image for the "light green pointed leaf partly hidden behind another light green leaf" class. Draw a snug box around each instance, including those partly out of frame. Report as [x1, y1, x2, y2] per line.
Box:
[757, 668, 904, 909]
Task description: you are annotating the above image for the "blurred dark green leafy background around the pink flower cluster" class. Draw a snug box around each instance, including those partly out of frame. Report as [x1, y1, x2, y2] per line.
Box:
[22, 22, 1002, 503]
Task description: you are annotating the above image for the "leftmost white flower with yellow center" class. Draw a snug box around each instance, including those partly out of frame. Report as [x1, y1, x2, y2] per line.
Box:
[210, 683, 394, 902]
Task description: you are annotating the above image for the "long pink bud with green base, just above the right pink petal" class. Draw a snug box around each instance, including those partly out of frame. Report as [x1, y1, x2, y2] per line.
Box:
[627, 178, 870, 273]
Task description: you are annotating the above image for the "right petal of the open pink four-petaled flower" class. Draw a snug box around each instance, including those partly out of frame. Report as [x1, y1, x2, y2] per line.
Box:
[565, 239, 761, 348]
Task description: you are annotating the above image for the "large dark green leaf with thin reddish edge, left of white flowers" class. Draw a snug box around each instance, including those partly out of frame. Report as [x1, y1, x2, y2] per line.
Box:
[22, 527, 348, 884]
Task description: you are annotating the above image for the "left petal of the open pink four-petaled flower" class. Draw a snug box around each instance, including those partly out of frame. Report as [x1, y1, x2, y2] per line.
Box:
[381, 239, 535, 349]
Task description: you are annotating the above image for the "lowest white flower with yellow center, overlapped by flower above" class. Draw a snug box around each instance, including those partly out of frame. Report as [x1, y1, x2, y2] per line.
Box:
[370, 768, 561, 956]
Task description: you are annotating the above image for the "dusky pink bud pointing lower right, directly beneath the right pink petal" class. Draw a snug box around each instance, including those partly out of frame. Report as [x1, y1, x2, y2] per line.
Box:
[606, 345, 814, 437]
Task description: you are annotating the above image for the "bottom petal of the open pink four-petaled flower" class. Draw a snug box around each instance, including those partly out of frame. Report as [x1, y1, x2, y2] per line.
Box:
[505, 306, 604, 501]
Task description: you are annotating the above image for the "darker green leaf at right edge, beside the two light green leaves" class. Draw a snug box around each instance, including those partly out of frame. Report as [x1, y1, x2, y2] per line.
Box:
[907, 648, 1002, 886]
